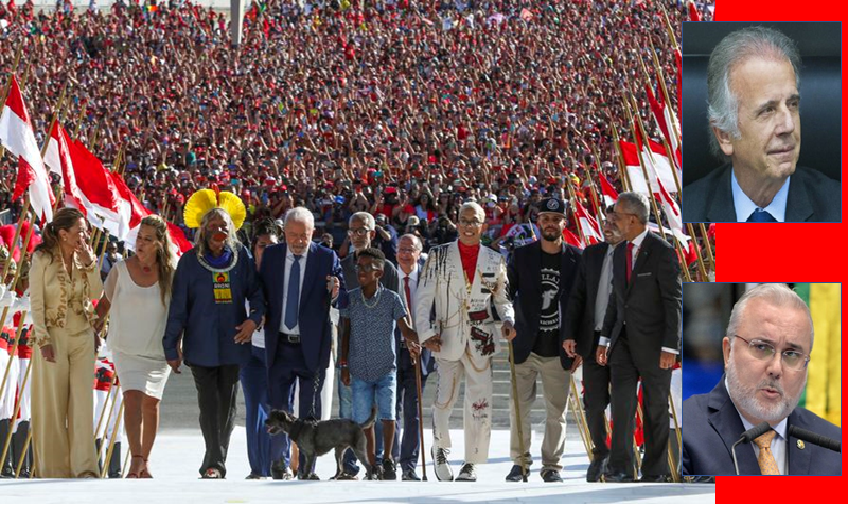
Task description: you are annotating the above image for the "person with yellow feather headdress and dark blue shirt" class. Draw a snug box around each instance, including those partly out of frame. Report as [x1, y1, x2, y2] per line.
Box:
[163, 189, 264, 479]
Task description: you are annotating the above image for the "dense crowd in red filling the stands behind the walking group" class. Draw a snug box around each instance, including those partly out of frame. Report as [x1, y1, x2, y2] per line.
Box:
[0, 0, 711, 266]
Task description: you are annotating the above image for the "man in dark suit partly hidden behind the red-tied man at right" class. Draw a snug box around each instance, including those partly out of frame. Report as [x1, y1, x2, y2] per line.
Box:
[561, 205, 623, 482]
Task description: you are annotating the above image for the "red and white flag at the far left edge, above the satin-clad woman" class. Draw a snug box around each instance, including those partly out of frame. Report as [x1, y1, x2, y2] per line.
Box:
[0, 76, 56, 222]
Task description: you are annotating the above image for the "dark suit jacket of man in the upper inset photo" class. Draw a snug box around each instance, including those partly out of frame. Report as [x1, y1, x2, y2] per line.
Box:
[682, 165, 841, 223]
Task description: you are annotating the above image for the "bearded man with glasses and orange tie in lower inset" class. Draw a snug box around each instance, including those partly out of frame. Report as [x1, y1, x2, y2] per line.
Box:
[682, 284, 842, 475]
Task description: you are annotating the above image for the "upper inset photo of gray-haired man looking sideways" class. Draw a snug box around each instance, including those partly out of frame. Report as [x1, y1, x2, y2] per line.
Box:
[682, 22, 843, 223]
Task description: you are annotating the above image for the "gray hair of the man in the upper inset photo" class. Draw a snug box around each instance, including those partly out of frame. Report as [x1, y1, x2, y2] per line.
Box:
[707, 26, 800, 161]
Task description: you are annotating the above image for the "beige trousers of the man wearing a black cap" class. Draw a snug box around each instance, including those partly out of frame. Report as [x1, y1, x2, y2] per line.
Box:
[510, 353, 570, 471]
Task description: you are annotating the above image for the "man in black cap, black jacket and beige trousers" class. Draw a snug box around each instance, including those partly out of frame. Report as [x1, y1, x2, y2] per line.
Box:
[506, 198, 581, 482]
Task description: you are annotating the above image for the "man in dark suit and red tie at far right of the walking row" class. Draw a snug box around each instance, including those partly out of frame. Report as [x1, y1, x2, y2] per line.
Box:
[596, 193, 682, 482]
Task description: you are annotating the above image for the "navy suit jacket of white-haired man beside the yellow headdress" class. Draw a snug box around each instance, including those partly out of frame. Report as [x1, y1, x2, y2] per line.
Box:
[260, 242, 348, 371]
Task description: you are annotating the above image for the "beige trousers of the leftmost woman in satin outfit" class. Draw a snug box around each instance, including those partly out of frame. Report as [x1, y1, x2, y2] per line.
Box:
[32, 328, 100, 478]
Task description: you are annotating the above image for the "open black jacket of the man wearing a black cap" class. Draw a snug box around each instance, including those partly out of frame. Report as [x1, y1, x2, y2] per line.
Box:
[508, 240, 581, 370]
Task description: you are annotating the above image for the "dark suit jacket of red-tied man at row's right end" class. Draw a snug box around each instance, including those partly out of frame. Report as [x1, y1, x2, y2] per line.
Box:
[602, 232, 682, 364]
